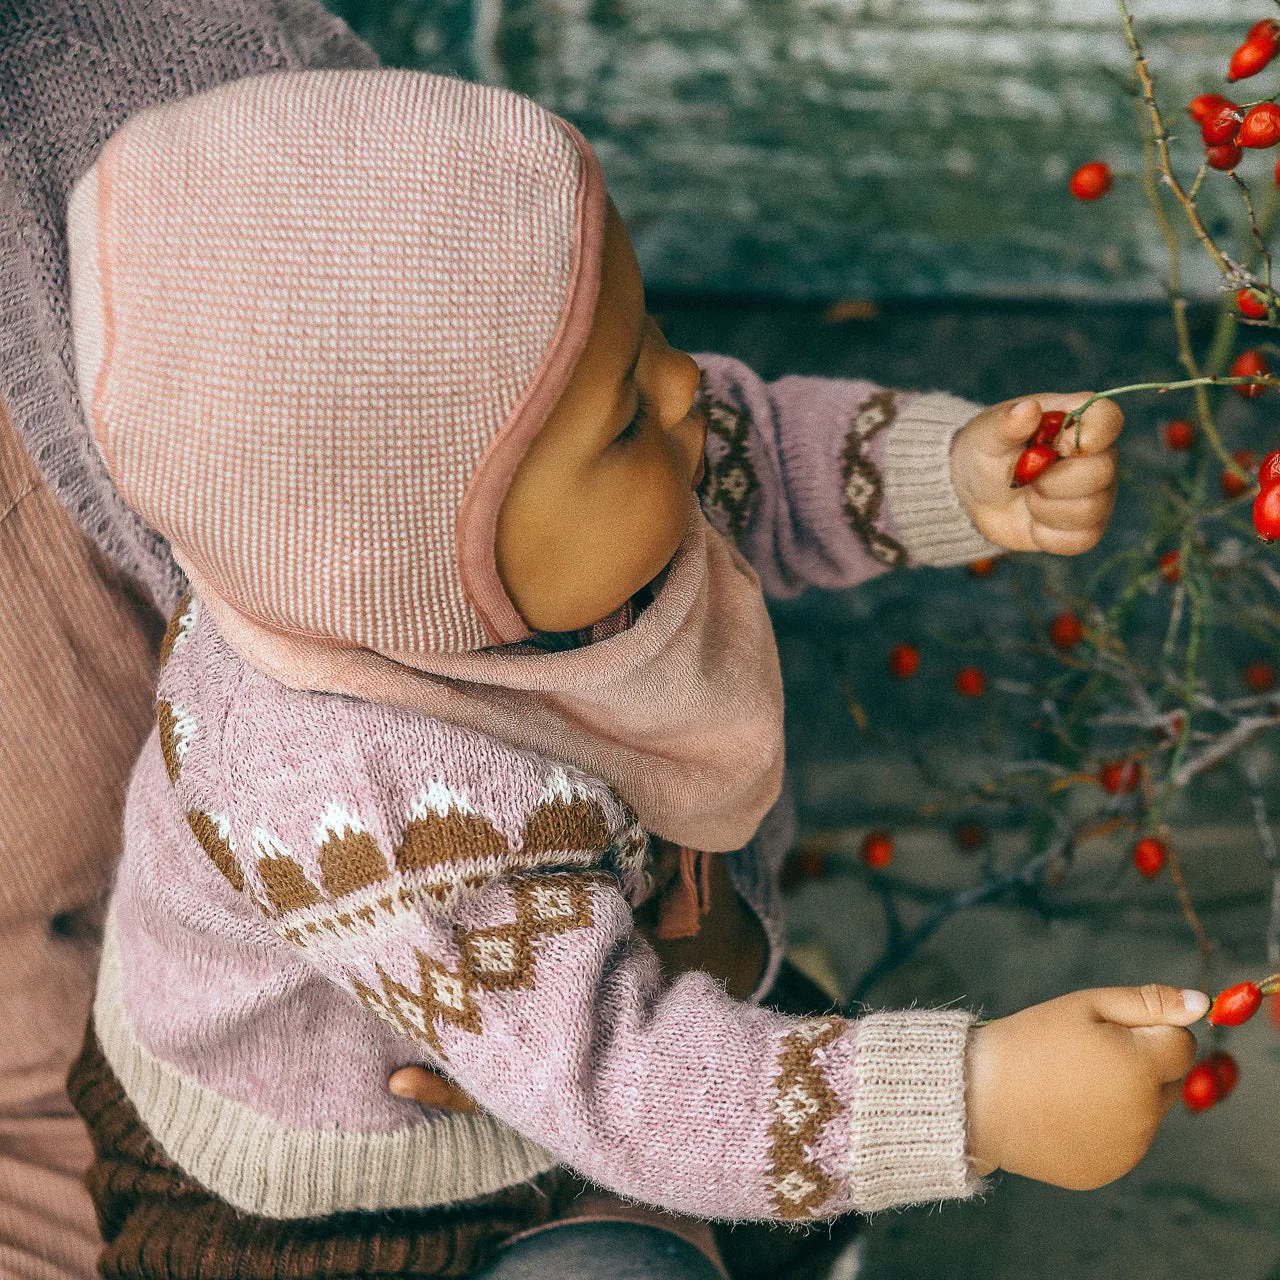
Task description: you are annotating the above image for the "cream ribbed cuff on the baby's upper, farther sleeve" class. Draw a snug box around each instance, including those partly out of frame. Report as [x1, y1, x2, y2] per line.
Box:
[882, 392, 1004, 564]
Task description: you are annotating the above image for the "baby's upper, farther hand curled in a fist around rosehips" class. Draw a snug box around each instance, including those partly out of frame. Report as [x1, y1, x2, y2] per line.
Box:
[951, 392, 1124, 556]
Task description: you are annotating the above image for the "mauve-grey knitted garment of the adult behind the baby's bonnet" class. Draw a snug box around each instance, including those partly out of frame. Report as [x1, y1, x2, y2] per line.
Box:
[0, 0, 376, 614]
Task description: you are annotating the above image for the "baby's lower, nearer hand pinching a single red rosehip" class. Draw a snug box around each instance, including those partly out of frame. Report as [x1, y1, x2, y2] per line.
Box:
[968, 984, 1208, 1190]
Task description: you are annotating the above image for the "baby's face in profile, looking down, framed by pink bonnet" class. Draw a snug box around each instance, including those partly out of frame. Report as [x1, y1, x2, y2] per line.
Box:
[495, 205, 707, 631]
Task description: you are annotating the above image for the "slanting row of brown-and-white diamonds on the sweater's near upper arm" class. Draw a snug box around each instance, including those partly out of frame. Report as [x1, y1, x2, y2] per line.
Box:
[347, 872, 611, 1059]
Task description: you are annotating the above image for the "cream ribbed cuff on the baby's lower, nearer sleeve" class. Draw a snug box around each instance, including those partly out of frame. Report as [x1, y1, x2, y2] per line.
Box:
[849, 1010, 983, 1213]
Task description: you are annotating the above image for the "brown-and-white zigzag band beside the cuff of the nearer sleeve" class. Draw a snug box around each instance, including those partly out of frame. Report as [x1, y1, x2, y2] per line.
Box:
[767, 1018, 847, 1220]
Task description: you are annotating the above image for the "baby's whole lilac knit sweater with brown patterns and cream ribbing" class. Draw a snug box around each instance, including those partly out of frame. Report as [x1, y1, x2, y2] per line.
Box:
[95, 357, 989, 1219]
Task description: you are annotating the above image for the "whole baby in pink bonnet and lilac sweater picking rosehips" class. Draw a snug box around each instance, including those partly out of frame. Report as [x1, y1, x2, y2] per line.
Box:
[69, 72, 1204, 1277]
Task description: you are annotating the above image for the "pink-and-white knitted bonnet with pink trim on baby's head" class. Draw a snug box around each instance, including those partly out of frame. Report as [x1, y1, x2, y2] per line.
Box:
[69, 70, 605, 655]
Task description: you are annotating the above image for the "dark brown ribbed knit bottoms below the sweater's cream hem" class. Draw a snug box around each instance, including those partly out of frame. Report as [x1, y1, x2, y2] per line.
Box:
[68, 1025, 585, 1280]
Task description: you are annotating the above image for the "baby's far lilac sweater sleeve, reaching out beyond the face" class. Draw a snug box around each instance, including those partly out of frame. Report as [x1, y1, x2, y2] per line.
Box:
[695, 355, 1000, 596]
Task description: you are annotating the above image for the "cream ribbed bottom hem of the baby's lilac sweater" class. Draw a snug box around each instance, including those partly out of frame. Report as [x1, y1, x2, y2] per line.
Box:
[93, 916, 558, 1219]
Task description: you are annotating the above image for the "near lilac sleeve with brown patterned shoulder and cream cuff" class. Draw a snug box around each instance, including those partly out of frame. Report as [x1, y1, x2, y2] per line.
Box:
[157, 603, 977, 1220]
